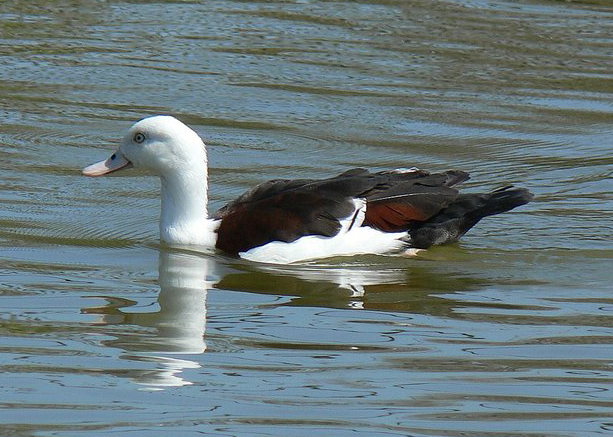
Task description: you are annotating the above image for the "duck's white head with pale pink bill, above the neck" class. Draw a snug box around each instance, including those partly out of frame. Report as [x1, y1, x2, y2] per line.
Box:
[83, 115, 207, 176]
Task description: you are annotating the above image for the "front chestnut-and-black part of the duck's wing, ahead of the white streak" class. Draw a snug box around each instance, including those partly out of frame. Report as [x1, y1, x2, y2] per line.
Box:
[213, 169, 377, 254]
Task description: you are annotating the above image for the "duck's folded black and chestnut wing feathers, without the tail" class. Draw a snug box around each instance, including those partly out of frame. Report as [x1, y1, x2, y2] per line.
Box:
[213, 168, 468, 254]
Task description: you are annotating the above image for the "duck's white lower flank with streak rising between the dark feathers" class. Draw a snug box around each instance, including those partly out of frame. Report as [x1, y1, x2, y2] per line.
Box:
[239, 199, 407, 264]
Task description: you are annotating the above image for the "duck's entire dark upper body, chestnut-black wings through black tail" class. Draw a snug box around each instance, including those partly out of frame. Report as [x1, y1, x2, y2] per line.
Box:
[214, 168, 531, 255]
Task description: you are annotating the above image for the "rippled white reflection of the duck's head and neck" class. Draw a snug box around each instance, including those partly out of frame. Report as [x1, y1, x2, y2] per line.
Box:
[83, 250, 212, 386]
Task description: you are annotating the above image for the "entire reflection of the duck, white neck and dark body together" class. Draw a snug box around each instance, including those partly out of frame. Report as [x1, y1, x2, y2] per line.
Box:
[83, 249, 492, 388]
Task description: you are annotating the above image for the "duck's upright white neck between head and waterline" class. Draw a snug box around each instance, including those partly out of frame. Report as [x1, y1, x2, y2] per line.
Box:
[160, 161, 216, 247]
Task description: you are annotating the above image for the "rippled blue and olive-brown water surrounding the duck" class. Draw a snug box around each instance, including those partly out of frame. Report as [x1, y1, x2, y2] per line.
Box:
[0, 0, 613, 437]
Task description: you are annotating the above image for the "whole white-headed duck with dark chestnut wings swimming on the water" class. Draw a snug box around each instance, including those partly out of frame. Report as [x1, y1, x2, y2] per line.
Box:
[82, 115, 533, 264]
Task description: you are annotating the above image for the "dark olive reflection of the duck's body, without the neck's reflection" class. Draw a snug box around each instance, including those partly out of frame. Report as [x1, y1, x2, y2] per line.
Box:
[215, 257, 491, 317]
